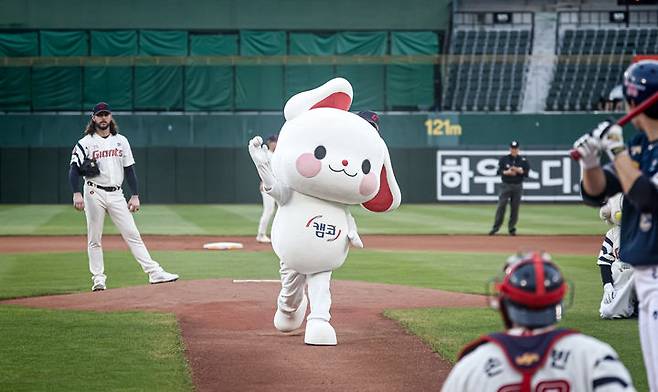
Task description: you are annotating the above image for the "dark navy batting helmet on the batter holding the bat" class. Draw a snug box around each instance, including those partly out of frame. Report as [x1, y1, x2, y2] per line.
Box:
[624, 60, 658, 119]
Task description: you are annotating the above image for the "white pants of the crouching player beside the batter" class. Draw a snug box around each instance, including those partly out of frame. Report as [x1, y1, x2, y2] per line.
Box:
[599, 261, 637, 319]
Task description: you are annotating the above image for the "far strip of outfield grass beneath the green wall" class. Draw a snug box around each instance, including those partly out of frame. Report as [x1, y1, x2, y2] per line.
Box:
[0, 204, 605, 235]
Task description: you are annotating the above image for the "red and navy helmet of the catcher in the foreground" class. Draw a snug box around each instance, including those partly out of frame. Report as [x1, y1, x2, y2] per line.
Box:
[495, 252, 567, 328]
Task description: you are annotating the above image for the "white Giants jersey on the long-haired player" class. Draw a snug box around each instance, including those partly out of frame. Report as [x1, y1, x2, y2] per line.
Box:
[71, 134, 135, 186]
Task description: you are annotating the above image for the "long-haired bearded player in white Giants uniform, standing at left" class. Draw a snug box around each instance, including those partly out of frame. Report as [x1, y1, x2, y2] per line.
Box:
[69, 102, 178, 291]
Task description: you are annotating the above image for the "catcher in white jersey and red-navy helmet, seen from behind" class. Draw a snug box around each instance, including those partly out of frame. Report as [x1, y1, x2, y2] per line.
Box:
[442, 252, 635, 392]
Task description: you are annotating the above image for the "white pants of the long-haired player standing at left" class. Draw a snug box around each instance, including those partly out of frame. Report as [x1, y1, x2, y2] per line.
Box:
[84, 185, 162, 280]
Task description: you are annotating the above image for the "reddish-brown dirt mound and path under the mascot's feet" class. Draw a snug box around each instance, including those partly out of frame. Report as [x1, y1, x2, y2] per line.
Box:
[4, 280, 484, 392]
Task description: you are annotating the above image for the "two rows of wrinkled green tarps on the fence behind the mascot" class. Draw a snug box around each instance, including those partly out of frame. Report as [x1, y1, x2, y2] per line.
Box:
[0, 30, 439, 112]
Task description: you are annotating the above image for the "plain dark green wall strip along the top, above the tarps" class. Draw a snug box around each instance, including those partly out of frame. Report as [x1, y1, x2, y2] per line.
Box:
[0, 0, 451, 30]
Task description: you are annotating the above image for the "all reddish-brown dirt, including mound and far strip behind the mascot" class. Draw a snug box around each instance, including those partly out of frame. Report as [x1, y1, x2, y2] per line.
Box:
[0, 236, 601, 392]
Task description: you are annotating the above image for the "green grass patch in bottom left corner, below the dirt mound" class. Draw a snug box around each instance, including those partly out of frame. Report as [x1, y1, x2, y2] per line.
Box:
[0, 306, 193, 391]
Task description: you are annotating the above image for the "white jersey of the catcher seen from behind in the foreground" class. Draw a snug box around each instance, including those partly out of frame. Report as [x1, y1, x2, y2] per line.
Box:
[442, 333, 635, 392]
